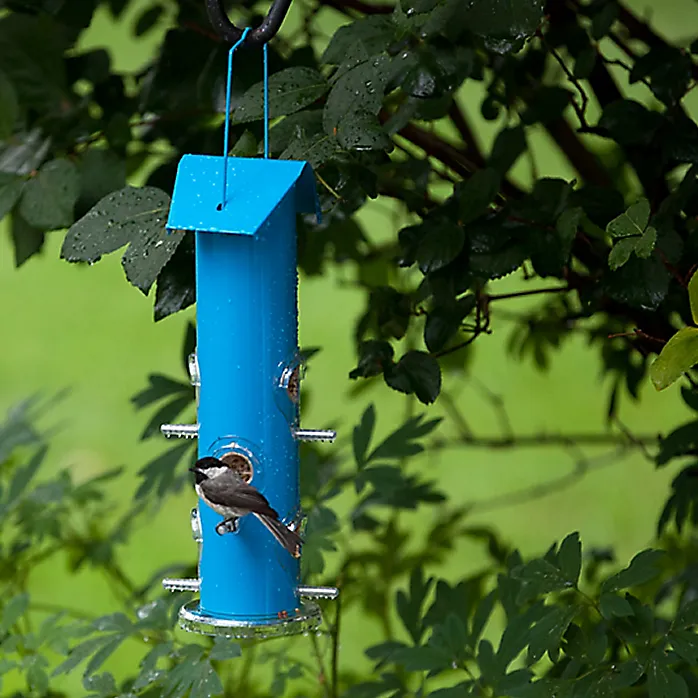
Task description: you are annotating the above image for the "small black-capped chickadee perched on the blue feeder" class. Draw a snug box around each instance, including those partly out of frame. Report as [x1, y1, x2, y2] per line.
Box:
[189, 456, 303, 557]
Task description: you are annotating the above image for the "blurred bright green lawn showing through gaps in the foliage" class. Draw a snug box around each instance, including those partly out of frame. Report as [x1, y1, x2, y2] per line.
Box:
[0, 0, 697, 684]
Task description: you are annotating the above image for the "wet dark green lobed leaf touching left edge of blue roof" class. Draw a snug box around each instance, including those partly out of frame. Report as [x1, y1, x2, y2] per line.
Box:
[61, 187, 184, 293]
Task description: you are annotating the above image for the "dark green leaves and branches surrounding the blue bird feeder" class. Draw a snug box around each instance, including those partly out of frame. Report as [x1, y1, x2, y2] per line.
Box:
[0, 0, 698, 698]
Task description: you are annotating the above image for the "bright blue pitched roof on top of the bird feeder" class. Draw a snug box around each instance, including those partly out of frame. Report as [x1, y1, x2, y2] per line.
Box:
[167, 155, 320, 235]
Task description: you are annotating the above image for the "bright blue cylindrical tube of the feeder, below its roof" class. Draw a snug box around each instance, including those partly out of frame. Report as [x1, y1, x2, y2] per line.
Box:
[196, 196, 299, 622]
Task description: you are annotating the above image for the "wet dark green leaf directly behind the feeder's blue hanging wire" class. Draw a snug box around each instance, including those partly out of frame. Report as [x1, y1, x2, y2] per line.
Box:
[231, 66, 329, 124]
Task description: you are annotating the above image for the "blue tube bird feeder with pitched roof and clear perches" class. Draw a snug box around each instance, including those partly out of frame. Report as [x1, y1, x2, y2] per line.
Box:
[162, 155, 337, 637]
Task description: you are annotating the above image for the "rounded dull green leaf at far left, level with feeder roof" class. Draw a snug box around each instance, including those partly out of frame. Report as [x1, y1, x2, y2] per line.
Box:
[19, 159, 80, 230]
